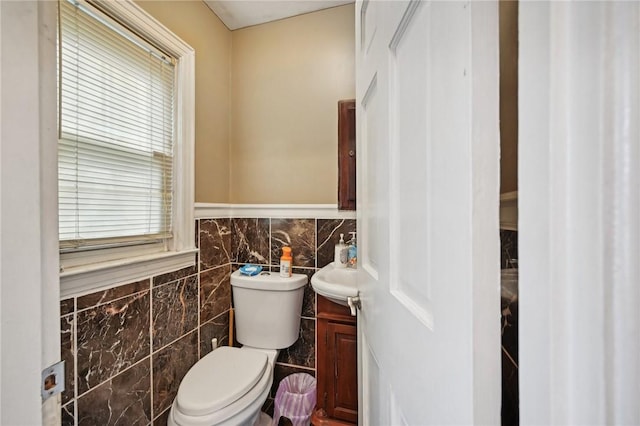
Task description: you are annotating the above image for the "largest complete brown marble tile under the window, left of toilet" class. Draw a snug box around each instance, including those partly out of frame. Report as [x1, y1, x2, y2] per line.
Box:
[76, 292, 150, 395]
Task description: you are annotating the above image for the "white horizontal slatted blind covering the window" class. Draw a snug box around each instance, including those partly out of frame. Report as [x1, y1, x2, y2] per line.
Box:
[58, 0, 174, 251]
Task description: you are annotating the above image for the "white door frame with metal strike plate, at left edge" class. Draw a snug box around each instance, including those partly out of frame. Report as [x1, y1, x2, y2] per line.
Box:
[0, 1, 60, 425]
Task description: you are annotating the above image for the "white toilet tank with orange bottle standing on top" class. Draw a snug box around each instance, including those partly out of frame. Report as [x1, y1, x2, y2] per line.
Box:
[231, 271, 308, 349]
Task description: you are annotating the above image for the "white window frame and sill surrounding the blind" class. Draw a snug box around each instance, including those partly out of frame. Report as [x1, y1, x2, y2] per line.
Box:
[60, 0, 197, 297]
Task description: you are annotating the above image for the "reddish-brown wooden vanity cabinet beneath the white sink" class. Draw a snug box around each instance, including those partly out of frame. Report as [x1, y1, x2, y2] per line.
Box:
[311, 295, 358, 426]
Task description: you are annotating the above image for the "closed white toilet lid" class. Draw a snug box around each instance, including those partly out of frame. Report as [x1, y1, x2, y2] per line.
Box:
[176, 346, 268, 416]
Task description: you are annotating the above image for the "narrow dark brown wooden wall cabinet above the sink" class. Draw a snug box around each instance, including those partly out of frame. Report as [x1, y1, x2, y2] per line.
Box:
[338, 99, 356, 210]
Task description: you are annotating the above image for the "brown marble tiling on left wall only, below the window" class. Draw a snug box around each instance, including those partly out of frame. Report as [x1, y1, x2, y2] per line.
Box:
[60, 219, 231, 426]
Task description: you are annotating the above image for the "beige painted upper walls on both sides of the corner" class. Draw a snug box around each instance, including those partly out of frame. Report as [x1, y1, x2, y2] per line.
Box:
[137, 0, 355, 203]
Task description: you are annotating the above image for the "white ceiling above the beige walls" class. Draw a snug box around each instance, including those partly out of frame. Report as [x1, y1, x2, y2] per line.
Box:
[203, 0, 354, 30]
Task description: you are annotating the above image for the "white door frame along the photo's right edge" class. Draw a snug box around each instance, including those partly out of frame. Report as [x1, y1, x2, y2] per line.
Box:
[518, 2, 640, 425]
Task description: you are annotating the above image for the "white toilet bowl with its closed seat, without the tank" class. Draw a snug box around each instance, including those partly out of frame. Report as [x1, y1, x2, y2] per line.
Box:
[168, 347, 277, 426]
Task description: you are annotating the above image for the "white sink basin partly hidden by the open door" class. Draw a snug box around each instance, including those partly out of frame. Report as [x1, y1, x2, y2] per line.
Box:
[311, 262, 358, 306]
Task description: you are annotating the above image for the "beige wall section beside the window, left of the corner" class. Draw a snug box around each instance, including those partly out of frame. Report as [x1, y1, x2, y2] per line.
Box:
[137, 0, 231, 203]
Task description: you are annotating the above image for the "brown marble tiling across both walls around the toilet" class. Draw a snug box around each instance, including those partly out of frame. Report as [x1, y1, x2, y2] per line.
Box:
[60, 218, 356, 426]
